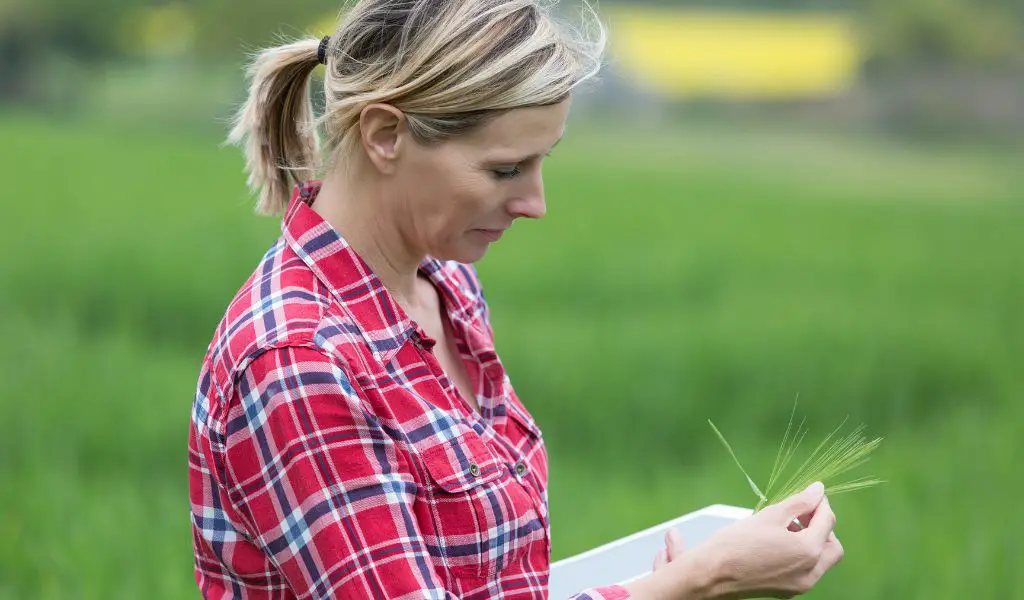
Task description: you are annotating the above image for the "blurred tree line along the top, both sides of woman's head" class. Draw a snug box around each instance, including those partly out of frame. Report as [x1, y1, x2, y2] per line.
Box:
[0, 0, 1024, 138]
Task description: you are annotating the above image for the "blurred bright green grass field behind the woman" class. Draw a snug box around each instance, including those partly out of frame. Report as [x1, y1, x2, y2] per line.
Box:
[0, 117, 1024, 600]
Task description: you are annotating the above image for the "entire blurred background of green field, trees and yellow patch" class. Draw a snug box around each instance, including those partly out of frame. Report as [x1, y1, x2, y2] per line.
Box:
[0, 0, 1024, 600]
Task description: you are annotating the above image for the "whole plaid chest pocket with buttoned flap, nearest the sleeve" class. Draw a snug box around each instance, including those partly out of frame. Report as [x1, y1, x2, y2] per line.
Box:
[421, 429, 544, 580]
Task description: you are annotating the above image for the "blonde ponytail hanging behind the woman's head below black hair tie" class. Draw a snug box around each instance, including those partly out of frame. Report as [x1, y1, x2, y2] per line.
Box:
[227, 39, 321, 215]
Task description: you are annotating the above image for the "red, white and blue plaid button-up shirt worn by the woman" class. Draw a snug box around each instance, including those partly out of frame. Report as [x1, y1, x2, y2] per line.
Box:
[188, 182, 628, 599]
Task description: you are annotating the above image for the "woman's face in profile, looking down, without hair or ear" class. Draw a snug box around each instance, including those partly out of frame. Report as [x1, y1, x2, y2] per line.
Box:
[388, 100, 569, 263]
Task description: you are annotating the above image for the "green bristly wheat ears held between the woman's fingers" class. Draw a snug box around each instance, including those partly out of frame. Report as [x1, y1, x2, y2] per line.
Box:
[708, 396, 883, 512]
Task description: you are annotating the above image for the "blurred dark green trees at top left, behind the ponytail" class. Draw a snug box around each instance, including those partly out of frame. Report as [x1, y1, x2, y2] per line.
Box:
[0, 0, 331, 102]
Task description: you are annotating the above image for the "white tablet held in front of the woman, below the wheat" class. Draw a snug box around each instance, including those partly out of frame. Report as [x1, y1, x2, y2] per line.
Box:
[548, 504, 754, 600]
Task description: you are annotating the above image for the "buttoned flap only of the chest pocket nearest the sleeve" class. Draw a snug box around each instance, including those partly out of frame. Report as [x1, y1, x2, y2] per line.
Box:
[422, 431, 502, 494]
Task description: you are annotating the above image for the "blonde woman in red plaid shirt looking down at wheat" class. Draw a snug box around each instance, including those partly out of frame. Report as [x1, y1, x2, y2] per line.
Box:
[189, 0, 842, 599]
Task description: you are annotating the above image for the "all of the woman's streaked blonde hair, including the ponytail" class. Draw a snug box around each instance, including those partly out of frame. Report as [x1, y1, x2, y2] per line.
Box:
[227, 0, 606, 214]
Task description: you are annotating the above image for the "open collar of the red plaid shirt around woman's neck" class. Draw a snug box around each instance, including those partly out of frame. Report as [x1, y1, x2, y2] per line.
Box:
[282, 181, 478, 363]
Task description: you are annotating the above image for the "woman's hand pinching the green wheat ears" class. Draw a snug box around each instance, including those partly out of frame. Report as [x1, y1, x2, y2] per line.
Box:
[653, 484, 843, 600]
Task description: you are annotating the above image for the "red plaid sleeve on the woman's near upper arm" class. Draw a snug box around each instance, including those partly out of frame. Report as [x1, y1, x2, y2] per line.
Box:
[224, 347, 454, 600]
